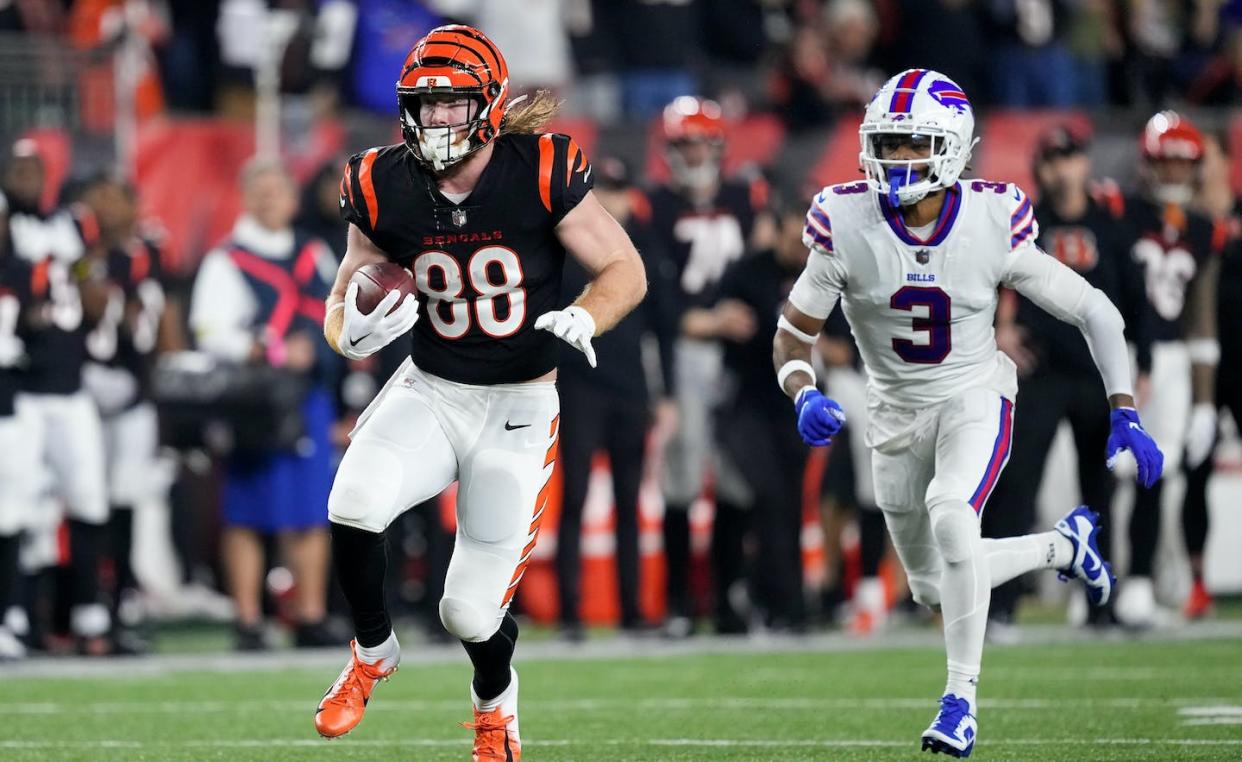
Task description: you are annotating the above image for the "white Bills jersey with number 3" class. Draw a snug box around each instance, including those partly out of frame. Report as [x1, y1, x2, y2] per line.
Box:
[789, 180, 1129, 454]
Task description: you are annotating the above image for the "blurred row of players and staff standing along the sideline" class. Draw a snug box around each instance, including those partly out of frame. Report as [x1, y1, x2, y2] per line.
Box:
[0, 97, 1242, 658]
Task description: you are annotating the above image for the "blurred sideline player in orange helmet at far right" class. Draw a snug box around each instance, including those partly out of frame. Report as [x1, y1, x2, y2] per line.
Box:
[1114, 112, 1228, 627]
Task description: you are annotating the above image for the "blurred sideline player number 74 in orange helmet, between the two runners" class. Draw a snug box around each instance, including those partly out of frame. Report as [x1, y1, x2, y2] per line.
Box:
[651, 96, 768, 637]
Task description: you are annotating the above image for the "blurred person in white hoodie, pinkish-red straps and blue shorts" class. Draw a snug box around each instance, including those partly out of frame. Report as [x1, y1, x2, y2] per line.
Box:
[190, 160, 337, 650]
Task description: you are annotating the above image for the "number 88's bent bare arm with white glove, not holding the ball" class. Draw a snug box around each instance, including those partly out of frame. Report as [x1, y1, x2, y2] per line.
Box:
[535, 191, 647, 367]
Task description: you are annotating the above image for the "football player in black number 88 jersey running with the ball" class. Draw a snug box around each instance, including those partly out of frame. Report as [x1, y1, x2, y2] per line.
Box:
[315, 26, 646, 760]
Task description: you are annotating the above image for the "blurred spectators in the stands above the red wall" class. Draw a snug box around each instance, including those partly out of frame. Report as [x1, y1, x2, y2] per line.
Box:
[7, 0, 1242, 129]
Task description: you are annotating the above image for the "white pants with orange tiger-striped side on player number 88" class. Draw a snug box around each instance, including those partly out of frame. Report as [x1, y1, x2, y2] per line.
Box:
[328, 360, 560, 642]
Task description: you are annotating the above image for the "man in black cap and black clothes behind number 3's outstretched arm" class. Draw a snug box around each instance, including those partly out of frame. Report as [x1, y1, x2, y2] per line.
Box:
[982, 124, 1151, 632]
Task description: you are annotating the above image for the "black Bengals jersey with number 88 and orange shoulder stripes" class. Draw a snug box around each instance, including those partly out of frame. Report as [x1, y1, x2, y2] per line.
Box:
[340, 133, 594, 385]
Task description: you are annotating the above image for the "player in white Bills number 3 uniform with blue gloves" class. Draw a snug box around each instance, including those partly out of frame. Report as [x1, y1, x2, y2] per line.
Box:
[774, 69, 1163, 757]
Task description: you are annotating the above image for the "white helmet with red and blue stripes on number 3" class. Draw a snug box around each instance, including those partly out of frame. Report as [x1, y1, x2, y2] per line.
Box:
[858, 68, 979, 206]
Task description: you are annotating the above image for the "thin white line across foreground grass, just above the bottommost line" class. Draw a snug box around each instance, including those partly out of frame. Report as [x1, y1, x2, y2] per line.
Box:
[0, 696, 1242, 716]
